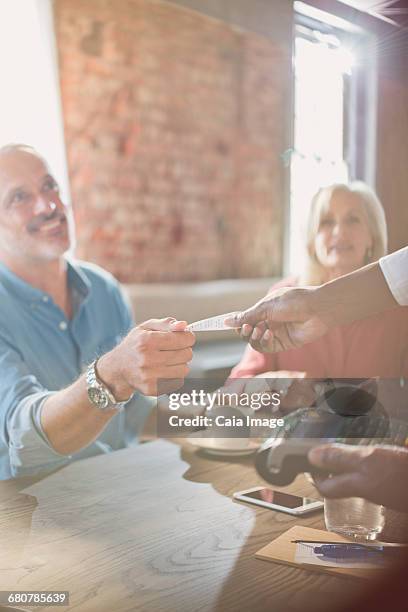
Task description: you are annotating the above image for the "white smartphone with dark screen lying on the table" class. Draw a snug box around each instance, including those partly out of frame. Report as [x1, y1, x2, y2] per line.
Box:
[233, 487, 324, 516]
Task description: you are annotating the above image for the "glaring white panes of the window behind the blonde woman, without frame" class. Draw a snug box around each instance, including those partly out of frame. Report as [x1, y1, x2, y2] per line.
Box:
[289, 36, 354, 273]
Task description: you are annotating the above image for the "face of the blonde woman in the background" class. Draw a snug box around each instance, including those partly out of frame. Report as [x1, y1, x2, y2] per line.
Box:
[314, 191, 372, 276]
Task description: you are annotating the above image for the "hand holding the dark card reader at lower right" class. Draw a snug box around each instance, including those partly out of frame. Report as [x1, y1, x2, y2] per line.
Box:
[308, 444, 408, 512]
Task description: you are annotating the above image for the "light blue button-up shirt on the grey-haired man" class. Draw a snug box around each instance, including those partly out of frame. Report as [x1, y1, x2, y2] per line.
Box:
[0, 261, 152, 479]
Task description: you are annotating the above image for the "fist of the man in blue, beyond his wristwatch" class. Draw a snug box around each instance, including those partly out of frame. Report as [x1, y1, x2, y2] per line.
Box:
[98, 318, 195, 400]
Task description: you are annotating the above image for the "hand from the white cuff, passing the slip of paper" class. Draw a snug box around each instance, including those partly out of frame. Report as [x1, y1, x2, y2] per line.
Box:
[225, 287, 328, 353]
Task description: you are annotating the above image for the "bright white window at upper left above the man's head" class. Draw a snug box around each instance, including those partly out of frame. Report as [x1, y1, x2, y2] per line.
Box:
[0, 0, 69, 198]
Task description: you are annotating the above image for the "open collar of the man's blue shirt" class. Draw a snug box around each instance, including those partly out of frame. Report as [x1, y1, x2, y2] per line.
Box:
[0, 259, 91, 302]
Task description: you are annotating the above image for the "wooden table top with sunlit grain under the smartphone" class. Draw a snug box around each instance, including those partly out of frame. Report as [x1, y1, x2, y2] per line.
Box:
[0, 441, 372, 612]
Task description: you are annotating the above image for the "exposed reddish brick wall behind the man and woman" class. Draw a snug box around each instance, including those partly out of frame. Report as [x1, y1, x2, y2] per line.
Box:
[55, 0, 288, 282]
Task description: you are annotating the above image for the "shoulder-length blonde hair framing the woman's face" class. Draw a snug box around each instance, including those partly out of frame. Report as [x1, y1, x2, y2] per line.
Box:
[301, 181, 387, 285]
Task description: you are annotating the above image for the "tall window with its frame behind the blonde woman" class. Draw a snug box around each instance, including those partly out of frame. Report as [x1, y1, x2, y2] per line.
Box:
[287, 3, 374, 273]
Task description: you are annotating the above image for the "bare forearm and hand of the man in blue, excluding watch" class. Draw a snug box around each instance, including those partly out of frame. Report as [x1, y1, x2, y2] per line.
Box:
[41, 319, 195, 455]
